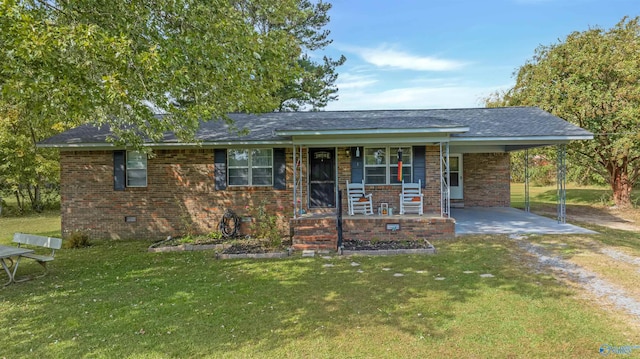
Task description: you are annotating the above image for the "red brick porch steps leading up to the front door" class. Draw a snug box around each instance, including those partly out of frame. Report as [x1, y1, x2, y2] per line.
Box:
[290, 217, 338, 251]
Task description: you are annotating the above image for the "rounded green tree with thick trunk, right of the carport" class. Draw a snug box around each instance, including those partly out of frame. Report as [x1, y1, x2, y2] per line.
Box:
[486, 17, 640, 208]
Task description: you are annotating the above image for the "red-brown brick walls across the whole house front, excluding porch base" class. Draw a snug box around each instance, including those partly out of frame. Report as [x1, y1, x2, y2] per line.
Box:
[60, 146, 509, 239]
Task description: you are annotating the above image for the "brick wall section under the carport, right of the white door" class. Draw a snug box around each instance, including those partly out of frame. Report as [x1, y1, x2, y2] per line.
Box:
[463, 153, 511, 207]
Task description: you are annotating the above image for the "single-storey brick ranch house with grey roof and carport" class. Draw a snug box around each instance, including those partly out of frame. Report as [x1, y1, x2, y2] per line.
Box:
[39, 107, 592, 249]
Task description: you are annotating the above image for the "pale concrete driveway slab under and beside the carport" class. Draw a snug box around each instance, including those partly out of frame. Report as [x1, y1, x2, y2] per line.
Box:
[451, 207, 597, 235]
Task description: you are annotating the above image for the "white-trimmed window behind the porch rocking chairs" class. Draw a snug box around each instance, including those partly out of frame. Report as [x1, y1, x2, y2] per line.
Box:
[364, 147, 413, 184]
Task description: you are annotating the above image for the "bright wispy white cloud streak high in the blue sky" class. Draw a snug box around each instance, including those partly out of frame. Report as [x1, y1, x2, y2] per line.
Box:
[345, 45, 465, 71]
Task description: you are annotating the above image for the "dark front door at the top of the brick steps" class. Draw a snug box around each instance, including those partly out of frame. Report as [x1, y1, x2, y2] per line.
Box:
[309, 148, 336, 208]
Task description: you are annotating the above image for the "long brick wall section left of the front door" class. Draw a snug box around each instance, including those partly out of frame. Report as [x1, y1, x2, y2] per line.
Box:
[60, 149, 293, 239]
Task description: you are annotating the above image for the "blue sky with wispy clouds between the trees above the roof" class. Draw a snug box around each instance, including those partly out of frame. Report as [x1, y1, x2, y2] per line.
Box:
[324, 0, 640, 110]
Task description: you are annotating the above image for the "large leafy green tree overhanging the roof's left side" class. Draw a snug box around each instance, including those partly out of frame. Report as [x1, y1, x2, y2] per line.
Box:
[0, 0, 344, 209]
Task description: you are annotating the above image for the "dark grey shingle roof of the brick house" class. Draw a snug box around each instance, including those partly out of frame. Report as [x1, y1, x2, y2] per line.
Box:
[40, 107, 591, 147]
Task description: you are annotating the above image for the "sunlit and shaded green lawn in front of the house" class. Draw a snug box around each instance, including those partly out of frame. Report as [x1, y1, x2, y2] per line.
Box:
[0, 187, 640, 358]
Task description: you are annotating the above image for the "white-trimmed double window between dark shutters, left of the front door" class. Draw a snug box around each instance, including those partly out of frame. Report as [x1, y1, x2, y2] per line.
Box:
[227, 148, 273, 186]
